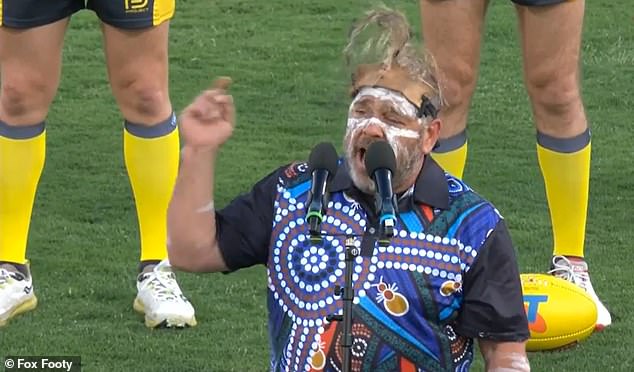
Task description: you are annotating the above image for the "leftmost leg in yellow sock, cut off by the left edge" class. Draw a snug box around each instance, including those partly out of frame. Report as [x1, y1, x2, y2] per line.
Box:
[0, 0, 77, 326]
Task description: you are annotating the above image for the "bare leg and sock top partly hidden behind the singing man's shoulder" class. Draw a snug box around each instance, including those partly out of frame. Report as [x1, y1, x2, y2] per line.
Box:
[420, 0, 488, 178]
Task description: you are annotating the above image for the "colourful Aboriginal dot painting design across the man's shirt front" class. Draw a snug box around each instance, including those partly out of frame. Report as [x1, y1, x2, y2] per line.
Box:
[267, 176, 492, 371]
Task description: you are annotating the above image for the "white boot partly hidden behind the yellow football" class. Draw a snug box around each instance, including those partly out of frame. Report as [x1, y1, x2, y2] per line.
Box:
[548, 256, 612, 331]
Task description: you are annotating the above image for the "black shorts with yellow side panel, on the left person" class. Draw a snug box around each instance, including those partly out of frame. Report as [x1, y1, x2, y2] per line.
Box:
[0, 0, 176, 29]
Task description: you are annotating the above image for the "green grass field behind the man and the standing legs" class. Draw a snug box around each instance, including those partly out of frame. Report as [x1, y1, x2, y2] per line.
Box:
[0, 0, 634, 371]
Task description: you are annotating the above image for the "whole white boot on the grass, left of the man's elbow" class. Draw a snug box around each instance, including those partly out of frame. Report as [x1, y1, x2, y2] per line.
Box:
[134, 260, 196, 328]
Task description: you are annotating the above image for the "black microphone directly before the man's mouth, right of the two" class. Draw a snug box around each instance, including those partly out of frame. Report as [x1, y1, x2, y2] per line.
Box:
[365, 141, 398, 244]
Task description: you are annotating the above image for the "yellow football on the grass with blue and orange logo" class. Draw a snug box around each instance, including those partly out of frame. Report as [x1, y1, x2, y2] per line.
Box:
[520, 274, 597, 351]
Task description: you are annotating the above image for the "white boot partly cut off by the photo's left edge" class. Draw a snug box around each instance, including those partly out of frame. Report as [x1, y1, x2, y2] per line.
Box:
[0, 264, 37, 327]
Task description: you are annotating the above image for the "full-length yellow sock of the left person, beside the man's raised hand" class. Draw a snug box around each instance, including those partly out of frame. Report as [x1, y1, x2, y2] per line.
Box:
[123, 115, 180, 261]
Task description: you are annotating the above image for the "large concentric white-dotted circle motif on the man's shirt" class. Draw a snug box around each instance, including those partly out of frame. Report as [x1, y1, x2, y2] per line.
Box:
[268, 192, 373, 327]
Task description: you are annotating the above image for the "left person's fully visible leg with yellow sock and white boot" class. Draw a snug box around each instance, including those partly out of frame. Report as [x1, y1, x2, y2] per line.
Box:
[89, 0, 196, 327]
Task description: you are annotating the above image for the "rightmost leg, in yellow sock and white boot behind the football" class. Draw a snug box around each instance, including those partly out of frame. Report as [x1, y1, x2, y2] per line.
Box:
[517, 0, 611, 328]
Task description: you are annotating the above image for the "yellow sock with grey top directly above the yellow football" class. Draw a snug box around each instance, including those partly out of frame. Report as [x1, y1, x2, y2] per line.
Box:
[537, 130, 591, 257]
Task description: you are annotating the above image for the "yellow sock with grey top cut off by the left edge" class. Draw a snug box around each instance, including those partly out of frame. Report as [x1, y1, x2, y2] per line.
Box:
[0, 121, 46, 264]
